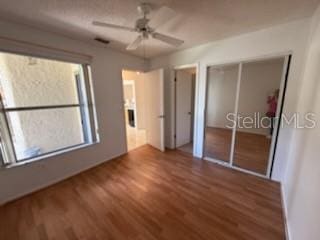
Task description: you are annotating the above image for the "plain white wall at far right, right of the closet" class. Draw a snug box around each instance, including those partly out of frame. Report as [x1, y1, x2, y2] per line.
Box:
[283, 4, 320, 240]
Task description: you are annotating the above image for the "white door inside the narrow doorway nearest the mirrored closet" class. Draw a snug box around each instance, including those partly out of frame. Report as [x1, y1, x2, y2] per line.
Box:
[176, 70, 192, 147]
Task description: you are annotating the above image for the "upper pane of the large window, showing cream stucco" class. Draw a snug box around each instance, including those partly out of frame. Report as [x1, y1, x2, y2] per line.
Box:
[0, 53, 82, 108]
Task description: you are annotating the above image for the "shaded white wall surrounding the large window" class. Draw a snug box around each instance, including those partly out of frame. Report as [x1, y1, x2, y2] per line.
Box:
[0, 19, 145, 204]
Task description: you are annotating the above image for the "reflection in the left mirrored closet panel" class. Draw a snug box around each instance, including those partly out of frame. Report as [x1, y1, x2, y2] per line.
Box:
[204, 64, 239, 162]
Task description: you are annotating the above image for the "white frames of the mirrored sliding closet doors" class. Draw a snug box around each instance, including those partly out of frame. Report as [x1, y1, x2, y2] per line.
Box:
[202, 51, 292, 178]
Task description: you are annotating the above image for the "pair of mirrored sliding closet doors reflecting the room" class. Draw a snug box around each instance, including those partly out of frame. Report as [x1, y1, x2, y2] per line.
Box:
[203, 56, 291, 177]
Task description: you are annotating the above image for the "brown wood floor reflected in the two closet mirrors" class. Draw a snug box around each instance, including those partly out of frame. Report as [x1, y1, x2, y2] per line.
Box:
[205, 127, 271, 175]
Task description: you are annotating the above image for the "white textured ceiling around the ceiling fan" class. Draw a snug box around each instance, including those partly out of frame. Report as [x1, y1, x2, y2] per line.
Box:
[0, 0, 320, 57]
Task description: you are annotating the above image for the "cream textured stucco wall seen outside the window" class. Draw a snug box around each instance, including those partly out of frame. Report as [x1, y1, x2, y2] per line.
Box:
[0, 53, 84, 160]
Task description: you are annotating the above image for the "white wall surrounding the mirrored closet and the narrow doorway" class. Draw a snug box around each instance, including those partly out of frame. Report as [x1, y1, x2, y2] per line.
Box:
[150, 19, 310, 183]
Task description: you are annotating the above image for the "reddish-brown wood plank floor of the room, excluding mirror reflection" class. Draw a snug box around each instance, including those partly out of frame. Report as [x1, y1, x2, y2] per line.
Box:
[0, 146, 285, 240]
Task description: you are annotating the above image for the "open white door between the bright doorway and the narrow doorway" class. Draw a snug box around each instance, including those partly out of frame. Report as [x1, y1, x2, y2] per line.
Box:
[144, 69, 164, 151]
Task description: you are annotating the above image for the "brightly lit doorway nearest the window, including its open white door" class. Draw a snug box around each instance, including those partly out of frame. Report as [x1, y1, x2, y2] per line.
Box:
[122, 69, 164, 151]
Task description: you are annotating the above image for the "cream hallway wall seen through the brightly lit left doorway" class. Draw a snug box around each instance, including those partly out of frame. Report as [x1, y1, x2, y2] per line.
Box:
[122, 70, 146, 129]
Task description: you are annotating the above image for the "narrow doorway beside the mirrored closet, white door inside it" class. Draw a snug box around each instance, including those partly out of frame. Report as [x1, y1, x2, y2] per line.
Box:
[174, 67, 197, 155]
